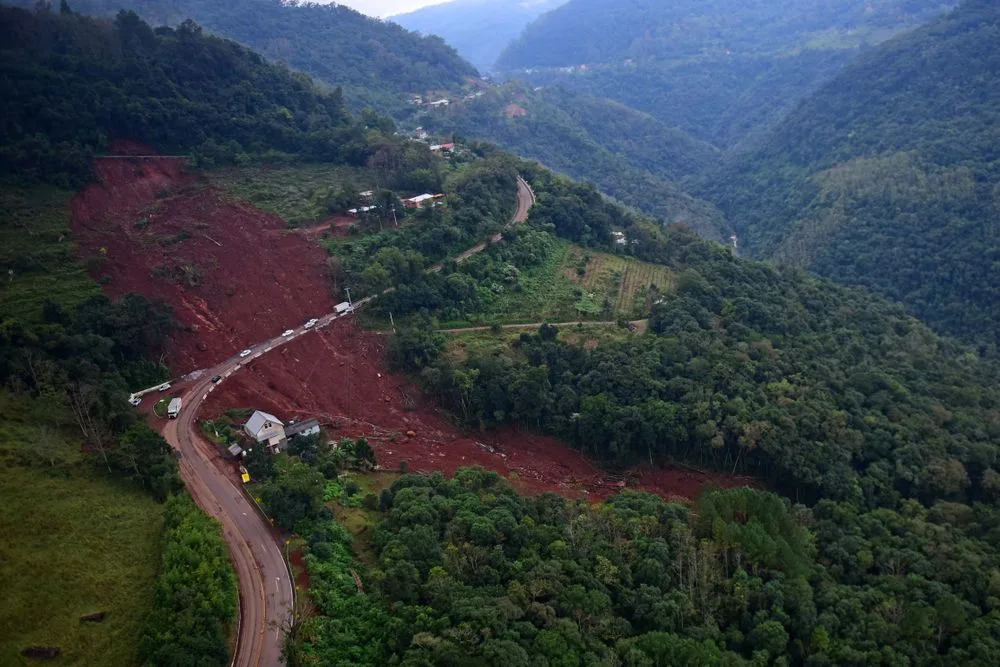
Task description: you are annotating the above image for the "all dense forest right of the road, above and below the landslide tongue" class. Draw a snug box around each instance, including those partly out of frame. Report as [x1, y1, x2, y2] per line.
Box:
[275, 163, 1000, 665]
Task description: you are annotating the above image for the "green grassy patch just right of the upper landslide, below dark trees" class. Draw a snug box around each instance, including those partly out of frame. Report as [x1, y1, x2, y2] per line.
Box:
[207, 165, 373, 227]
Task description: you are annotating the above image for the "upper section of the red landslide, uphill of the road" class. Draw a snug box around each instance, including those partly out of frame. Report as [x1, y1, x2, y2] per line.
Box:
[72, 151, 333, 375]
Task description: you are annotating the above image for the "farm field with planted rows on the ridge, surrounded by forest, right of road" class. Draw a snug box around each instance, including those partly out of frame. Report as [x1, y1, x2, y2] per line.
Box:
[483, 241, 675, 324]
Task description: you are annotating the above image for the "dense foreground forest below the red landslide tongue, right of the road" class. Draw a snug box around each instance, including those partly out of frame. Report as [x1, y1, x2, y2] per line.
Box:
[288, 469, 1000, 667]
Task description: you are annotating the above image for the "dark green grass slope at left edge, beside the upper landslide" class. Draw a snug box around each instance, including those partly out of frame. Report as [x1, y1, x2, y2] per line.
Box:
[0, 182, 101, 321]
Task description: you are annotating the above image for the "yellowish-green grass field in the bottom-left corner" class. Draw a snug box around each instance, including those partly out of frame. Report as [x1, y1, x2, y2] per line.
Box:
[0, 393, 162, 666]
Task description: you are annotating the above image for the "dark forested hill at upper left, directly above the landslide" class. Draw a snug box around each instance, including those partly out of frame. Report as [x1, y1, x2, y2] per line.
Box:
[0, 7, 368, 182]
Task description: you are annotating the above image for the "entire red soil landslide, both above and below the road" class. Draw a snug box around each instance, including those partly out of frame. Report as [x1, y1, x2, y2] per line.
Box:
[72, 150, 750, 500]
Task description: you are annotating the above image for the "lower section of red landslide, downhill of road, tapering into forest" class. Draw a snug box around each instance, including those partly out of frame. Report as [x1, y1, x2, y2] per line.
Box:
[202, 318, 749, 500]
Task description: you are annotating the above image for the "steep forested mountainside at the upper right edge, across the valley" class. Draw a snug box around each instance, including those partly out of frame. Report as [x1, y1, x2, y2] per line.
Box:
[702, 0, 1000, 345]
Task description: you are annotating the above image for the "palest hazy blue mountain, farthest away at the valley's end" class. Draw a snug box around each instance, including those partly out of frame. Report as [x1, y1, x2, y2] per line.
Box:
[390, 0, 566, 72]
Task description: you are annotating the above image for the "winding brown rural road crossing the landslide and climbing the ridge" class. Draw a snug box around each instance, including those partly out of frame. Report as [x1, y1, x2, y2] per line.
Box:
[154, 176, 535, 667]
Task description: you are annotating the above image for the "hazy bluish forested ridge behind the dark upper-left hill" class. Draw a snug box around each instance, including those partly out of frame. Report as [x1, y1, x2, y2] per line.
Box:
[8, 0, 476, 109]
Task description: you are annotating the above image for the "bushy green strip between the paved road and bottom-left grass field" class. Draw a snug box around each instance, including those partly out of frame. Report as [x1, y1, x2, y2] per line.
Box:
[141, 496, 239, 667]
